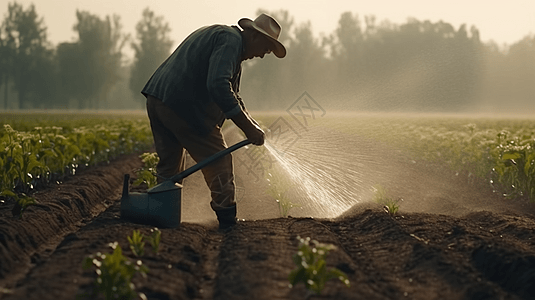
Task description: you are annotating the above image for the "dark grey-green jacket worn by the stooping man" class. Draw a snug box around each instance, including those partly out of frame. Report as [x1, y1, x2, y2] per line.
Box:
[141, 25, 246, 135]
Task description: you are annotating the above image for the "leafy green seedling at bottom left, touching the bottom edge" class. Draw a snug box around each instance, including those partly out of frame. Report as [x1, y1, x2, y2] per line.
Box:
[84, 242, 148, 300]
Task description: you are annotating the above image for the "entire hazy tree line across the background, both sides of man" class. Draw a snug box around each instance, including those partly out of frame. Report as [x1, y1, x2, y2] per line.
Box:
[0, 2, 535, 112]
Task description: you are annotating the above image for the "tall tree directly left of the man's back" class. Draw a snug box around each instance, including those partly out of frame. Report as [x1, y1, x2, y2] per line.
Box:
[129, 8, 173, 103]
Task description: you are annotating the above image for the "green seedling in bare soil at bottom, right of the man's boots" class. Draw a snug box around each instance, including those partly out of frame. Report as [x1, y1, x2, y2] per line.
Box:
[288, 236, 350, 295]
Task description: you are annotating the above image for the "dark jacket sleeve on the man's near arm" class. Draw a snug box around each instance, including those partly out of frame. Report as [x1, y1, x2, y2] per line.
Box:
[206, 33, 242, 119]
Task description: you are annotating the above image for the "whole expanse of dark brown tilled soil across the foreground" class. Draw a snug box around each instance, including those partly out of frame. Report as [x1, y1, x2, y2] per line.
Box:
[0, 137, 535, 299]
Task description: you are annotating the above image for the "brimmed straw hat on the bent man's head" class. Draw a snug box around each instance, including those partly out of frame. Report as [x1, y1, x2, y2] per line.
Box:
[238, 14, 286, 58]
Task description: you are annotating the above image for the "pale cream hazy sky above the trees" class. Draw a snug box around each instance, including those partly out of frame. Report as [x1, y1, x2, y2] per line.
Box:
[0, 0, 535, 54]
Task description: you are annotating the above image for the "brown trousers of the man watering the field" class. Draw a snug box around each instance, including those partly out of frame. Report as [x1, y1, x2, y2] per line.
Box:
[147, 95, 236, 212]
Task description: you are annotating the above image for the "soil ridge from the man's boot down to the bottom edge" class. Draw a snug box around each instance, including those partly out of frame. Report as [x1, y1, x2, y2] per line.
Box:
[214, 219, 294, 299]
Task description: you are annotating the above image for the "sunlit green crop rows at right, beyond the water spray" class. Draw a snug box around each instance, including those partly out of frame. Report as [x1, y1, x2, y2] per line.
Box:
[322, 115, 535, 201]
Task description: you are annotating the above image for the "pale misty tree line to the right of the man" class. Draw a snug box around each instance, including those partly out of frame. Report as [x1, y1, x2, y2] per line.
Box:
[242, 11, 535, 114]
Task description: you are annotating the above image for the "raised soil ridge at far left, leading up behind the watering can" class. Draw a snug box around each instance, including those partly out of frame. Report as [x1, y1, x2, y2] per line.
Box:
[0, 154, 142, 288]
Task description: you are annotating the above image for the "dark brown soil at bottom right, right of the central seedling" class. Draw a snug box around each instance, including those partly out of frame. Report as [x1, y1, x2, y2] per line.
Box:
[332, 210, 535, 299]
